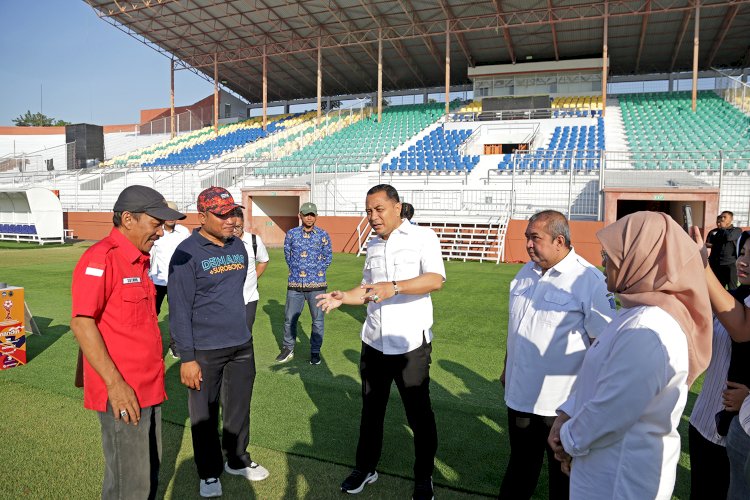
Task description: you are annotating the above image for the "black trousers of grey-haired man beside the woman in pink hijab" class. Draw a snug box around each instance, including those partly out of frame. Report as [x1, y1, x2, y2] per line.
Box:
[498, 408, 570, 500]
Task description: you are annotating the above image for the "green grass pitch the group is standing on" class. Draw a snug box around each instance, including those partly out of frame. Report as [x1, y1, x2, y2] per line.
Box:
[0, 243, 699, 499]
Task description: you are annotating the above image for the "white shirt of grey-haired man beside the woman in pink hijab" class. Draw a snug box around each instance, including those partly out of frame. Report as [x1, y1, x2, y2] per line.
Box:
[505, 248, 615, 417]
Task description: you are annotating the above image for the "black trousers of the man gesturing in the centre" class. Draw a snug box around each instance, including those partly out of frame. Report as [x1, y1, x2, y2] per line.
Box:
[356, 341, 437, 480]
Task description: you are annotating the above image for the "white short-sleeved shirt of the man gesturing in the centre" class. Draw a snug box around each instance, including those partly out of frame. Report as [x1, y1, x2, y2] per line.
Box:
[362, 219, 445, 354]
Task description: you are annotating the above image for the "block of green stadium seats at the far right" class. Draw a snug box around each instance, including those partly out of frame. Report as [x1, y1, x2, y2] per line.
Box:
[619, 92, 750, 170]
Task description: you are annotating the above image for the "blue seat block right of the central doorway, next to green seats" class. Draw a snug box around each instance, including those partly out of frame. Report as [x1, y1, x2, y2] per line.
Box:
[497, 118, 604, 171]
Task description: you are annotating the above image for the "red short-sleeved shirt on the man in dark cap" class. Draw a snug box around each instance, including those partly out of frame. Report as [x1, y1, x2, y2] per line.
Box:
[72, 228, 166, 411]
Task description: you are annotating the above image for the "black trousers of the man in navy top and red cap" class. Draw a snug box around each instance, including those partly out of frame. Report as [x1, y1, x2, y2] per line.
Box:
[188, 339, 255, 479]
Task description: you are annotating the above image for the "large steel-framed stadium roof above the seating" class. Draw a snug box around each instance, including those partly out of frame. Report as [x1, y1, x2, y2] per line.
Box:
[85, 0, 750, 102]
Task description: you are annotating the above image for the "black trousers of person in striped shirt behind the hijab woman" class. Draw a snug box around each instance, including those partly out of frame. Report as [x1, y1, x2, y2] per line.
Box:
[688, 424, 729, 500]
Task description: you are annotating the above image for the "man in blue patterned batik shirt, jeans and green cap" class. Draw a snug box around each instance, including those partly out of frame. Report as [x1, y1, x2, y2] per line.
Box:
[276, 203, 333, 365]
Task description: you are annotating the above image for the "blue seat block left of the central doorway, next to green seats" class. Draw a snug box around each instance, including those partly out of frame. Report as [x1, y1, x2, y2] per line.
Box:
[381, 126, 479, 172]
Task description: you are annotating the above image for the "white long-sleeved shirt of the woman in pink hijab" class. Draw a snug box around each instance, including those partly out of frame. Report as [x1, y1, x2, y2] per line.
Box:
[560, 306, 688, 500]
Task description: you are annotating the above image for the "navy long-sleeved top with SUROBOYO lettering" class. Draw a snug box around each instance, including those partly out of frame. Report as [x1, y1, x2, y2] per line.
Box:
[167, 229, 251, 361]
